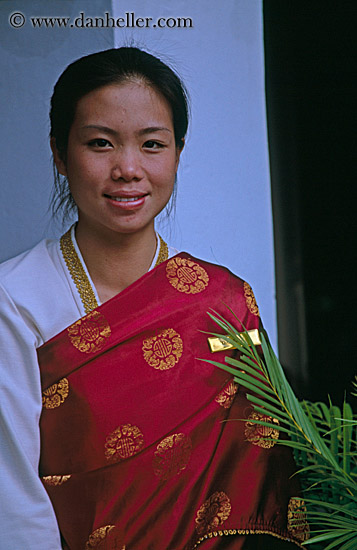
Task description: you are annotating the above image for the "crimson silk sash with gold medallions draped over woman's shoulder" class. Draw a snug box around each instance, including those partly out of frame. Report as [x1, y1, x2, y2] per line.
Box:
[38, 253, 305, 550]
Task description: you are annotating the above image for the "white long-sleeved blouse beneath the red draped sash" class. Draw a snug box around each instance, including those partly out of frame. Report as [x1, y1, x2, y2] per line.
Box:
[0, 228, 177, 550]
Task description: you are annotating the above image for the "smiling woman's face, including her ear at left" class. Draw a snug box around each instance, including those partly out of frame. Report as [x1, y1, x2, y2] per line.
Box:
[52, 81, 180, 239]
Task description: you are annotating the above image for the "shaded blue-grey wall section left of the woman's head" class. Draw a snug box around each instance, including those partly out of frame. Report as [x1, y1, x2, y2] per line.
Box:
[0, 0, 113, 261]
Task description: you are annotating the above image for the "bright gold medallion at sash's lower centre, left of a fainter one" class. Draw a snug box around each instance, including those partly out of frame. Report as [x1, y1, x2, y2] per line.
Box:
[104, 424, 144, 462]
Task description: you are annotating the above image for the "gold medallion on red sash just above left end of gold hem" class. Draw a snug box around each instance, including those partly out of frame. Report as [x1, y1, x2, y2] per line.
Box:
[195, 491, 232, 535]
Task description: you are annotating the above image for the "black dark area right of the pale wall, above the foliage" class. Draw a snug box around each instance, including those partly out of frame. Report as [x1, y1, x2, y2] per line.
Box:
[263, 0, 357, 405]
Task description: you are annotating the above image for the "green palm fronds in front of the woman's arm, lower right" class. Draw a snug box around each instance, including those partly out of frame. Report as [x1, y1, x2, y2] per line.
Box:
[203, 312, 357, 550]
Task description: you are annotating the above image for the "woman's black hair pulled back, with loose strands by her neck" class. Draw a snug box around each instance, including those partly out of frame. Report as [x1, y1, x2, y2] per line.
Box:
[50, 47, 189, 217]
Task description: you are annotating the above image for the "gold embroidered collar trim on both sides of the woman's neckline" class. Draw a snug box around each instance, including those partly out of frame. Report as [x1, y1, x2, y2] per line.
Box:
[60, 228, 169, 314]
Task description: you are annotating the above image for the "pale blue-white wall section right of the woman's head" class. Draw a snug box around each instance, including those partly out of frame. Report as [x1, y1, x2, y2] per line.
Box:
[112, 0, 277, 347]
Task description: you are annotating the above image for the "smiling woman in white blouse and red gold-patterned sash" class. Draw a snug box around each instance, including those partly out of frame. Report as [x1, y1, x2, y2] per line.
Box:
[0, 48, 306, 550]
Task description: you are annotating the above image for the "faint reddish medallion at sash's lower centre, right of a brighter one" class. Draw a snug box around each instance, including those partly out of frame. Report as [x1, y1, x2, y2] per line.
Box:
[153, 433, 192, 481]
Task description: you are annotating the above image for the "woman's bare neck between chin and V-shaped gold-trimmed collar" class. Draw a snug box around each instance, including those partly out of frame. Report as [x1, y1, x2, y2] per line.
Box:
[76, 222, 157, 303]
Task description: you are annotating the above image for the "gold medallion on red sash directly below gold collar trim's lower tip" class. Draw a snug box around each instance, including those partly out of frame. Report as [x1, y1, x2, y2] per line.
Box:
[67, 311, 111, 353]
